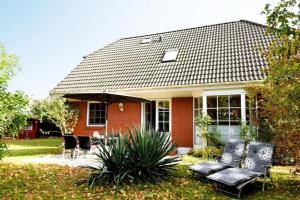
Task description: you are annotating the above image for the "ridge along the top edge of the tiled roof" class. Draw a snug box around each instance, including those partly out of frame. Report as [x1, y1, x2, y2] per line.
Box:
[119, 19, 267, 40]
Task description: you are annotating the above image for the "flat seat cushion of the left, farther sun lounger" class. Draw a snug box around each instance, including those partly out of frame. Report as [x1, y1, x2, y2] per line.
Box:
[190, 162, 230, 175]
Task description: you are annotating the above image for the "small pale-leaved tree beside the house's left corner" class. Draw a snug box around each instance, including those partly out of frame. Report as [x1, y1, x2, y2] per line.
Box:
[31, 98, 79, 135]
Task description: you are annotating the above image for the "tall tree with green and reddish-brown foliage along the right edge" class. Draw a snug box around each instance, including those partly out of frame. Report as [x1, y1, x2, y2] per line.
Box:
[253, 0, 300, 164]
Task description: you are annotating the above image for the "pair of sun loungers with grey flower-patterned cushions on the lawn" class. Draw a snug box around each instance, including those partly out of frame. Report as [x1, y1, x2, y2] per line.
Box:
[189, 141, 275, 198]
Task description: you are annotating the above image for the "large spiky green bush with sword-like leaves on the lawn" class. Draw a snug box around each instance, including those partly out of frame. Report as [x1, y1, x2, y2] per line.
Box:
[83, 127, 179, 187]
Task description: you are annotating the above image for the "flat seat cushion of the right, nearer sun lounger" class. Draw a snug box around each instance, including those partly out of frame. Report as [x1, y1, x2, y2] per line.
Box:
[207, 168, 260, 186]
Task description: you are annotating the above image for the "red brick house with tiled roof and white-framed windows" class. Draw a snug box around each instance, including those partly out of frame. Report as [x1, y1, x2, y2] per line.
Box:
[50, 20, 273, 152]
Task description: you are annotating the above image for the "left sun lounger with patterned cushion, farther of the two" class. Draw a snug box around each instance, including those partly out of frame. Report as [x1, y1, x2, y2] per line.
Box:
[189, 140, 245, 180]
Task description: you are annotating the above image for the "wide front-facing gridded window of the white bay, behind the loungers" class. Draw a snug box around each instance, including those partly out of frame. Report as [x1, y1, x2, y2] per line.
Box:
[207, 95, 241, 141]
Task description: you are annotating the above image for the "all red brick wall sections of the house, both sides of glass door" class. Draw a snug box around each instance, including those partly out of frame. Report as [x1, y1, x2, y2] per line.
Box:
[74, 97, 193, 147]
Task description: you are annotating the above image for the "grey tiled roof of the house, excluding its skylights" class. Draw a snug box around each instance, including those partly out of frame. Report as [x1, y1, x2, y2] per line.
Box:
[51, 20, 273, 94]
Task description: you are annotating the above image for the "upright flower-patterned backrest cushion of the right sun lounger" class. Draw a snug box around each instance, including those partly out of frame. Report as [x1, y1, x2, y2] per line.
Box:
[243, 142, 275, 173]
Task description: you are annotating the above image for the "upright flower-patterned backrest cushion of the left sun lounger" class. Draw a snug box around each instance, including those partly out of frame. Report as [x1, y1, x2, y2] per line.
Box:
[220, 140, 245, 166]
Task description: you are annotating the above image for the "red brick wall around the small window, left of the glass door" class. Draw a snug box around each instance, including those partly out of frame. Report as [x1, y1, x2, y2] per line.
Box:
[74, 101, 141, 135]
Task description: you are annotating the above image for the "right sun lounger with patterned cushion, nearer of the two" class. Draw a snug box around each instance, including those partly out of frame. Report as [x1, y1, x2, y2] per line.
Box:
[207, 142, 275, 198]
